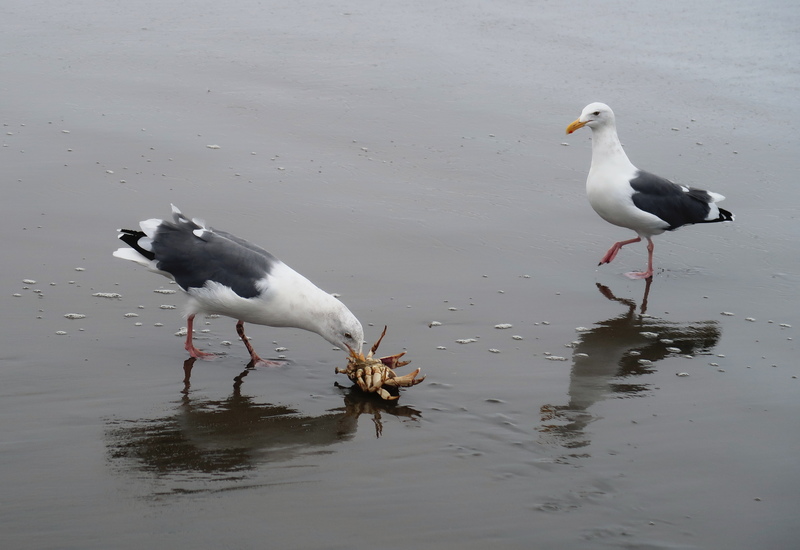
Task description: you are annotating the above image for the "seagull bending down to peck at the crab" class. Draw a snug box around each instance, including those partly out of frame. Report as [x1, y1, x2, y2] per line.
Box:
[114, 205, 364, 366]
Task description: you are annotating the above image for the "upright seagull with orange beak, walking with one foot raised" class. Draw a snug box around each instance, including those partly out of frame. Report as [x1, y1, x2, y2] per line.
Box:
[567, 103, 733, 279]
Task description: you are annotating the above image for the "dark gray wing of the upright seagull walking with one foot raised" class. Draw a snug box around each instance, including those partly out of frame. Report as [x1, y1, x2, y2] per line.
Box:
[630, 170, 722, 231]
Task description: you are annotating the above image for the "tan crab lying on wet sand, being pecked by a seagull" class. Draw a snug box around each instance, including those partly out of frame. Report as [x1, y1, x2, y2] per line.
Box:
[336, 327, 425, 401]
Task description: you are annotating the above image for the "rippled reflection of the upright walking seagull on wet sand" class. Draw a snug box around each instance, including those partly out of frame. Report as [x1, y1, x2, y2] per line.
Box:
[540, 281, 720, 447]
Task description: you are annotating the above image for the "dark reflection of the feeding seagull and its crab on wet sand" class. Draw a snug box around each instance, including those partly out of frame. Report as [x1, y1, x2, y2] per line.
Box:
[106, 358, 420, 491]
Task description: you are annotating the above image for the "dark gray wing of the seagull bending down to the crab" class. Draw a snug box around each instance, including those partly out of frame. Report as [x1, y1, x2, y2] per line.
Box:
[152, 220, 280, 298]
